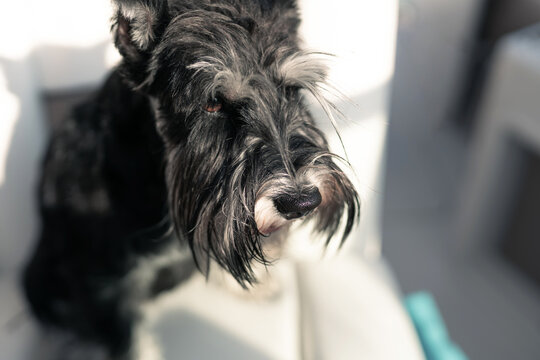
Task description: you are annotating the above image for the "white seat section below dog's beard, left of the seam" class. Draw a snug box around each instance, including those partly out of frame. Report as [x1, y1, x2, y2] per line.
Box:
[150, 261, 300, 360]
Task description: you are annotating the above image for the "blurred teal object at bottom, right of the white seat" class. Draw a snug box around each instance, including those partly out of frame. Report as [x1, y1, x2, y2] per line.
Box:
[405, 291, 468, 360]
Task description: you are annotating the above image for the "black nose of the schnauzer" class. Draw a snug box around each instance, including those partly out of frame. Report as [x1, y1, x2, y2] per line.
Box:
[274, 188, 322, 220]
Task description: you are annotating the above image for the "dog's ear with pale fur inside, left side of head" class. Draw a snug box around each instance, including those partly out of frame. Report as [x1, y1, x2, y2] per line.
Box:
[112, 0, 170, 86]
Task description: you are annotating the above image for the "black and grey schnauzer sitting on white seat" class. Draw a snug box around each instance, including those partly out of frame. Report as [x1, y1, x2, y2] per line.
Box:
[23, 0, 359, 359]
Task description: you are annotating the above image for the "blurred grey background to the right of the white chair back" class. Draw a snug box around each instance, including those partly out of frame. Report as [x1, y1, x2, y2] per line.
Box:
[382, 0, 540, 359]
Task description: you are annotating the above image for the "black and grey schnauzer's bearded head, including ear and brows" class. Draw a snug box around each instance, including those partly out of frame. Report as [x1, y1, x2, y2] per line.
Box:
[113, 0, 359, 284]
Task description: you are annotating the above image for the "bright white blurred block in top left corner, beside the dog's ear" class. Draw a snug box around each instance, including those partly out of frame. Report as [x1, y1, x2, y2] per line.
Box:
[0, 0, 112, 90]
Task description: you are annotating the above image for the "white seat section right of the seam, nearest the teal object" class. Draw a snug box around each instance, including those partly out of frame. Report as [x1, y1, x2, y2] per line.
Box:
[298, 256, 424, 360]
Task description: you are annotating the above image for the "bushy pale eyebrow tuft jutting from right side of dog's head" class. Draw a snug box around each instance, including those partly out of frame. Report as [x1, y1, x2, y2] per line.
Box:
[277, 53, 328, 87]
